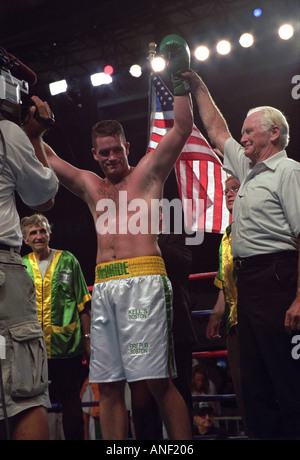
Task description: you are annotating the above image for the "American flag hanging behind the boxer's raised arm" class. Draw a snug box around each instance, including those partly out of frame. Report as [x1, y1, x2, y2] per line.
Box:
[147, 74, 230, 233]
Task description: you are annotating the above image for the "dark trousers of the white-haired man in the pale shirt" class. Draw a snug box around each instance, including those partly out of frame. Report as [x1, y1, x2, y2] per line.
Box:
[237, 252, 300, 439]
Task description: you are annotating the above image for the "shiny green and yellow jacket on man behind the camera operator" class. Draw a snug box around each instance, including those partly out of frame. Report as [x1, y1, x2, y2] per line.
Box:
[23, 250, 91, 358]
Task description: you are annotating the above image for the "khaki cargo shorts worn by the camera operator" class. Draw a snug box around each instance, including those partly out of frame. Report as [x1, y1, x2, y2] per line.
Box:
[0, 250, 49, 420]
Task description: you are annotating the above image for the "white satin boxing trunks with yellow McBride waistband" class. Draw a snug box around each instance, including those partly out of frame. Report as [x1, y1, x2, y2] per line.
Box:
[89, 256, 175, 382]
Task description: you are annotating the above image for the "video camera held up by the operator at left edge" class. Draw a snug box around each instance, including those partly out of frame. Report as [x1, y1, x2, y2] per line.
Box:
[0, 47, 37, 124]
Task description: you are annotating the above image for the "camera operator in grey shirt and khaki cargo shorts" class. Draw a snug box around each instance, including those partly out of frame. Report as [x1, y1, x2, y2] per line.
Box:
[0, 61, 58, 440]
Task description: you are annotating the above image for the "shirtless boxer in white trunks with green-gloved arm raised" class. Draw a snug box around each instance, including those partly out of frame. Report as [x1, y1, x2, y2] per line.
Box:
[41, 35, 193, 440]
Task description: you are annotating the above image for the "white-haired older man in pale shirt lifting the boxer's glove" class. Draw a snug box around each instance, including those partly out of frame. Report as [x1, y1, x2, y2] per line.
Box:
[184, 71, 300, 439]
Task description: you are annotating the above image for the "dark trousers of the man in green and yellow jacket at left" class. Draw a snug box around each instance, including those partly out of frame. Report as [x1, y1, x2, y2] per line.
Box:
[48, 356, 84, 440]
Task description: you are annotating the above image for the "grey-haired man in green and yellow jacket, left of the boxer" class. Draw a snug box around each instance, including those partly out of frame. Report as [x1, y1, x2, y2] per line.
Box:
[21, 214, 91, 439]
